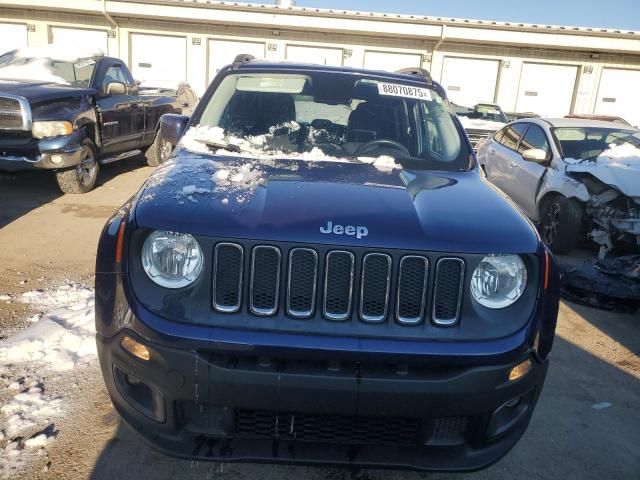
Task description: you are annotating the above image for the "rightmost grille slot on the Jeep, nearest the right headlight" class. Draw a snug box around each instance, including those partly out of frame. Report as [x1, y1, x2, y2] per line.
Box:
[433, 258, 464, 325]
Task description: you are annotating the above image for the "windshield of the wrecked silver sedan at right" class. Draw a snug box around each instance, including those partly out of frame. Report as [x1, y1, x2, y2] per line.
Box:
[553, 127, 640, 161]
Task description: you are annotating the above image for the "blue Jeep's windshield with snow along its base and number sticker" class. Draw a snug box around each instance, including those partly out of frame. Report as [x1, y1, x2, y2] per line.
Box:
[182, 72, 470, 170]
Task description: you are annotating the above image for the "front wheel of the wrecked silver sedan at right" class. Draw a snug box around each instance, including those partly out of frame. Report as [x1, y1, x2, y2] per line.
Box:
[540, 195, 583, 254]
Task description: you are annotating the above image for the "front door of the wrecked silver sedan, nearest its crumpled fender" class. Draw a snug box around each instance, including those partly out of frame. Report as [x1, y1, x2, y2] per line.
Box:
[509, 123, 551, 218]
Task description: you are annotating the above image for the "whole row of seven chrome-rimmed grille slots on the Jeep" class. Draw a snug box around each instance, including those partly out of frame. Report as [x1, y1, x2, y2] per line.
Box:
[213, 242, 465, 326]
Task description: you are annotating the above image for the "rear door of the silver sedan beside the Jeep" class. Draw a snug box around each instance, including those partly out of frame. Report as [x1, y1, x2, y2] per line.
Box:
[484, 123, 529, 198]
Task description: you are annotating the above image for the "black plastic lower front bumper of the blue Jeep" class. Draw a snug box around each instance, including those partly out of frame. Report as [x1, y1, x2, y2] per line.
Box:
[97, 330, 548, 471]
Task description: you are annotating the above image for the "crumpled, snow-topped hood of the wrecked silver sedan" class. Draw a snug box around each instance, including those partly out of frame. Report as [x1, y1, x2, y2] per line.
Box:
[565, 143, 640, 197]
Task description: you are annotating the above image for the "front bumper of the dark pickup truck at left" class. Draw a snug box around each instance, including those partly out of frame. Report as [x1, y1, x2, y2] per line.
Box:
[0, 130, 85, 172]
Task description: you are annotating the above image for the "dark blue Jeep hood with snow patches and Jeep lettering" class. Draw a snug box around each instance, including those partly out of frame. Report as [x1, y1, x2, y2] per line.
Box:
[133, 151, 538, 253]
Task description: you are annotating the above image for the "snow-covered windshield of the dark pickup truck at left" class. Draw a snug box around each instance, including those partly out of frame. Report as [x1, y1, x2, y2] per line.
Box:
[0, 50, 96, 88]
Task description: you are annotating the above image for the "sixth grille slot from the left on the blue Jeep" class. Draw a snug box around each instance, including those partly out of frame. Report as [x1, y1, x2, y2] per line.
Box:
[396, 255, 429, 325]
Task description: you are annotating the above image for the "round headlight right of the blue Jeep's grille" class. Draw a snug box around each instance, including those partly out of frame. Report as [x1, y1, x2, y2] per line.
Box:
[471, 255, 527, 308]
